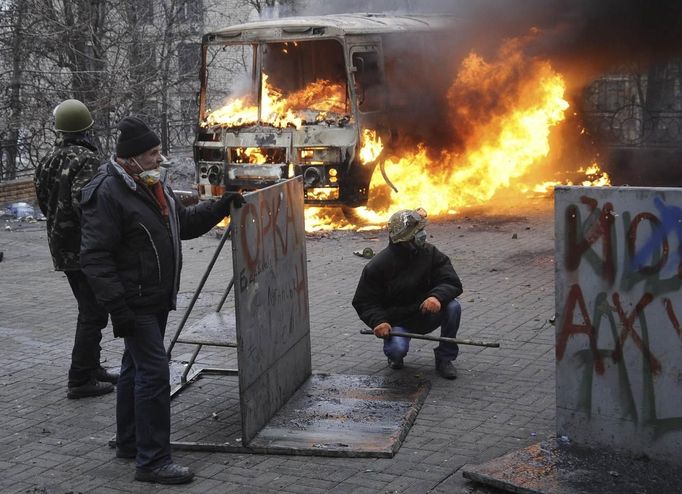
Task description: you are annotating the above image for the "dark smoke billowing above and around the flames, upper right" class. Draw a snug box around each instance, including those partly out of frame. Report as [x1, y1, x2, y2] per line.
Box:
[299, 0, 682, 183]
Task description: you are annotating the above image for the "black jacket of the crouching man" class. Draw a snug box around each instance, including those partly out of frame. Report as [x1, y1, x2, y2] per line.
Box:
[353, 243, 462, 329]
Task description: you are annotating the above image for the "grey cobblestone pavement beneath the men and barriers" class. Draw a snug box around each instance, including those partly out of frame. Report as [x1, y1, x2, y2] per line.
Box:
[0, 200, 555, 494]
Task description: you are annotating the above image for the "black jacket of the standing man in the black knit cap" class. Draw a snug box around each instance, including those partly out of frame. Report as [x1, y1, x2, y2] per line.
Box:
[80, 160, 225, 314]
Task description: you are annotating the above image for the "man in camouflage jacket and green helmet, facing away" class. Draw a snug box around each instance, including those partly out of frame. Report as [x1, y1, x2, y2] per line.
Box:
[34, 100, 118, 398]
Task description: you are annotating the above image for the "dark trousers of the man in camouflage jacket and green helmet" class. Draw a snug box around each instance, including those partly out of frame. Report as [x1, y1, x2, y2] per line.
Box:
[64, 270, 108, 387]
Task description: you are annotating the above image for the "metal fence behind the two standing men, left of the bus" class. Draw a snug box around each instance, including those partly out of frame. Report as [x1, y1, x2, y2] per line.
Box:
[0, 121, 194, 182]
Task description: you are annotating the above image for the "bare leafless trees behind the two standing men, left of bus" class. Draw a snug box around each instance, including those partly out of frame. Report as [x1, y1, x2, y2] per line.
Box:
[0, 0, 290, 180]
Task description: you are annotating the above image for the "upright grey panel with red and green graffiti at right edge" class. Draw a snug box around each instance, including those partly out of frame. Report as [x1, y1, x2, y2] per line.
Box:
[556, 187, 682, 444]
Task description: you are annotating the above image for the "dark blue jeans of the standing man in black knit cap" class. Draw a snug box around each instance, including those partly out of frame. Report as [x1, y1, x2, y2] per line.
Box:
[116, 311, 171, 470]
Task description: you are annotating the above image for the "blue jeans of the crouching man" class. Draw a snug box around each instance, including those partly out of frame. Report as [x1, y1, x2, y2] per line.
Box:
[384, 299, 462, 361]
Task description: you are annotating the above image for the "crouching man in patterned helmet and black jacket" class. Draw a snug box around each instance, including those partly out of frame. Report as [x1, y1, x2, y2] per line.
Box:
[353, 208, 462, 379]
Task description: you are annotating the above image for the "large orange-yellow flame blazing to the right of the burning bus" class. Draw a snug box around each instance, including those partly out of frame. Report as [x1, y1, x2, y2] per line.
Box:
[372, 65, 568, 215]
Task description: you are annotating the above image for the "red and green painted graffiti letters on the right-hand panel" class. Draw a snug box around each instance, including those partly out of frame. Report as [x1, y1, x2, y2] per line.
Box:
[556, 196, 682, 435]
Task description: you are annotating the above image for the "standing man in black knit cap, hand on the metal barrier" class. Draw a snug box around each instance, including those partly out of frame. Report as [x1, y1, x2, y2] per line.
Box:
[81, 117, 244, 484]
